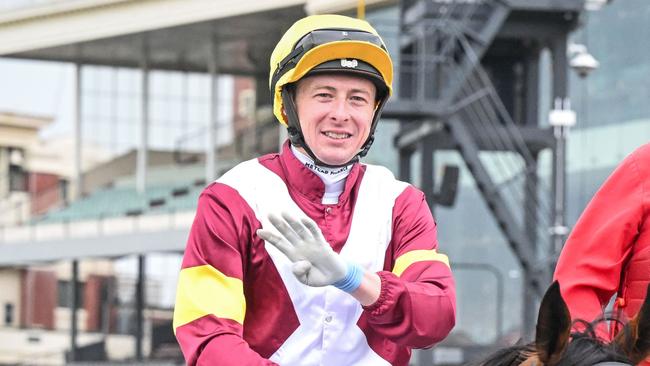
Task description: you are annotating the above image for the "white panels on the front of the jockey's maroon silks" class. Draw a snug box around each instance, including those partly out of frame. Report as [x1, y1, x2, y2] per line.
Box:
[218, 159, 406, 365]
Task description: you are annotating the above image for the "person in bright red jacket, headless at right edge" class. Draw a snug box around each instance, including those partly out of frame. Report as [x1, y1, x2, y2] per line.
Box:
[555, 144, 650, 365]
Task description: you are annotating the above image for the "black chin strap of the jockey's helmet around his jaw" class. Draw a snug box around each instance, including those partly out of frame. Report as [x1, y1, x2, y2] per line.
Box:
[282, 87, 387, 168]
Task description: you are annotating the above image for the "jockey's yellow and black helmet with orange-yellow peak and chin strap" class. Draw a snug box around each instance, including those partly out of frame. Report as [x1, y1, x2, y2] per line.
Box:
[269, 14, 393, 165]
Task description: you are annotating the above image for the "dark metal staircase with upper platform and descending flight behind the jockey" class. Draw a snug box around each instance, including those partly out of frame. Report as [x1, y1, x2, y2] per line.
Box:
[384, 0, 551, 294]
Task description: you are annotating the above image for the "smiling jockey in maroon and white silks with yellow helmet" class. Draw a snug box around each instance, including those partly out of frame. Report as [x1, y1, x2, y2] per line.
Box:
[174, 15, 456, 365]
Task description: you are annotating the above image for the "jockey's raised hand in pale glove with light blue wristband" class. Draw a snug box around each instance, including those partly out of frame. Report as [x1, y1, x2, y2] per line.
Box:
[257, 212, 363, 292]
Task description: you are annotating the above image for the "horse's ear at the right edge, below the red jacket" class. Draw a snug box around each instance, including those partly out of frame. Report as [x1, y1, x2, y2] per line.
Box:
[615, 284, 650, 365]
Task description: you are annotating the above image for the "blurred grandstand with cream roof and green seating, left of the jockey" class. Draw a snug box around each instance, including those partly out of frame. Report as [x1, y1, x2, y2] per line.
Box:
[0, 0, 306, 364]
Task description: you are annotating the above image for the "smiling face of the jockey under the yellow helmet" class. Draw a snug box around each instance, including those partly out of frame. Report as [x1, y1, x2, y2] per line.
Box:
[295, 74, 376, 165]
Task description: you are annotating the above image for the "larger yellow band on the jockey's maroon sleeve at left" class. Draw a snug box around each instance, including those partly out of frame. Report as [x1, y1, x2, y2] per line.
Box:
[173, 265, 246, 333]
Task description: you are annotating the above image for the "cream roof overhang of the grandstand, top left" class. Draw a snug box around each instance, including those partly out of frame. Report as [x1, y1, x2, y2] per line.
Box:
[0, 0, 306, 74]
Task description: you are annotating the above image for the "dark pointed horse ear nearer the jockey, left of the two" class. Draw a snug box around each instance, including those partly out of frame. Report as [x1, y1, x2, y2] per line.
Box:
[535, 281, 571, 365]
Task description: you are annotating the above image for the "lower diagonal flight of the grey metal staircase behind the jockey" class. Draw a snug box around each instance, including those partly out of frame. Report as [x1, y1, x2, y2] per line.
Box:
[442, 66, 551, 294]
